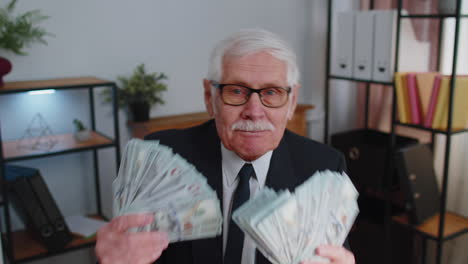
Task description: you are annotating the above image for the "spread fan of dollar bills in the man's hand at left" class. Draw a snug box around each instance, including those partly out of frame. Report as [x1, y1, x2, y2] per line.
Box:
[112, 139, 223, 242]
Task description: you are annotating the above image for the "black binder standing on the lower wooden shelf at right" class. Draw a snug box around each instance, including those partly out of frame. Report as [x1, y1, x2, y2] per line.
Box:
[395, 145, 440, 224]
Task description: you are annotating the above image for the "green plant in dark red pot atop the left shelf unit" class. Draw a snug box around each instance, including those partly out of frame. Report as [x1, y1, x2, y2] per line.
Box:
[0, 0, 51, 86]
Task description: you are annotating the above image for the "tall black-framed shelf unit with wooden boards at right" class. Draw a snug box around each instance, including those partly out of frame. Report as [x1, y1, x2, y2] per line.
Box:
[324, 0, 468, 264]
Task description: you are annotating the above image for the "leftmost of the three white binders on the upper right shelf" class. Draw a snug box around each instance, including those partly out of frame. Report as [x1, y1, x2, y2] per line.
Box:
[332, 12, 354, 78]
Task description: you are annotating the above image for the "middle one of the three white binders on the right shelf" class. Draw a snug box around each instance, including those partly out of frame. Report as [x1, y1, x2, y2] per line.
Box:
[353, 11, 374, 80]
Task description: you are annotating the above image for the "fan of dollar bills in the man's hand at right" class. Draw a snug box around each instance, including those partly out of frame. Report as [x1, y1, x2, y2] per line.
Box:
[232, 171, 359, 264]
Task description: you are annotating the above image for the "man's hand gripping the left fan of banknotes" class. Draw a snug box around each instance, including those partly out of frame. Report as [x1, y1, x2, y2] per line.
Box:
[96, 214, 169, 264]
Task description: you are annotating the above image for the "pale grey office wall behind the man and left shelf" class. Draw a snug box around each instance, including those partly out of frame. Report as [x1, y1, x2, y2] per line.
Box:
[0, 0, 346, 264]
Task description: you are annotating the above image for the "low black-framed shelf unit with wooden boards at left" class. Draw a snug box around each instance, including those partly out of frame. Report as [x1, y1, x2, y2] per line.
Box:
[0, 77, 120, 263]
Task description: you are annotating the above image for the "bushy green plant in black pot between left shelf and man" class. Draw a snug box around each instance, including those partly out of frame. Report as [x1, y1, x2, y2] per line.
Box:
[103, 64, 167, 122]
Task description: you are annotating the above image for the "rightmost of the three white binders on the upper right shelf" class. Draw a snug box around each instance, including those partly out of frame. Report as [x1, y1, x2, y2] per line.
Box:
[372, 10, 397, 82]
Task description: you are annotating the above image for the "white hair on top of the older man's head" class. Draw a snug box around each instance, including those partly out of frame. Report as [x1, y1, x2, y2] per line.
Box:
[207, 29, 299, 88]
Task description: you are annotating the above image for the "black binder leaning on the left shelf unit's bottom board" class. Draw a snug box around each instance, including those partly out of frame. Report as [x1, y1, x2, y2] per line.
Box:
[5, 165, 73, 252]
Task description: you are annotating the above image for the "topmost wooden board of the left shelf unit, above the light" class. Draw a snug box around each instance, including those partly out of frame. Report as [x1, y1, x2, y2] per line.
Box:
[0, 77, 114, 94]
